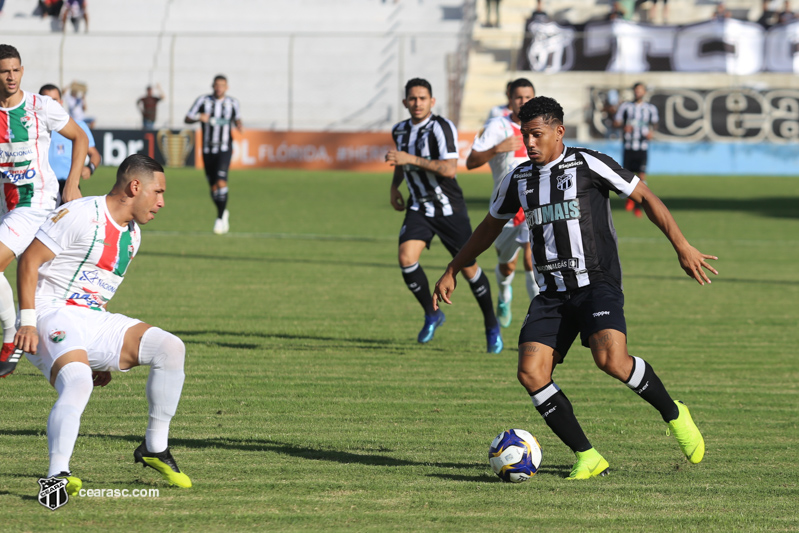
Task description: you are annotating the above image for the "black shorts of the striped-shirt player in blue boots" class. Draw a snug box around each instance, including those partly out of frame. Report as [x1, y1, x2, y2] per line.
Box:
[399, 209, 477, 267]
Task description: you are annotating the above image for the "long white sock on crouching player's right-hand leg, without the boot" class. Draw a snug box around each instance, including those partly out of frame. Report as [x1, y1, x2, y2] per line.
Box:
[139, 328, 186, 453]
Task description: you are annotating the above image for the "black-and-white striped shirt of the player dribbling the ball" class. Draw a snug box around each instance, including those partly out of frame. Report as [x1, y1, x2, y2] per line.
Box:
[490, 147, 640, 292]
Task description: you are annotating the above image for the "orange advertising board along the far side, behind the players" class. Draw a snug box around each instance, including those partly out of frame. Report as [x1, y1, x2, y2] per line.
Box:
[195, 130, 474, 172]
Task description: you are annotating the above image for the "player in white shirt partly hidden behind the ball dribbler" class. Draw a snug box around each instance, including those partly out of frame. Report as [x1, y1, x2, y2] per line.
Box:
[466, 78, 538, 328]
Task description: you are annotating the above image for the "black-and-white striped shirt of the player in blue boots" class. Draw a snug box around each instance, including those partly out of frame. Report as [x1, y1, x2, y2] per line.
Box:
[391, 114, 466, 217]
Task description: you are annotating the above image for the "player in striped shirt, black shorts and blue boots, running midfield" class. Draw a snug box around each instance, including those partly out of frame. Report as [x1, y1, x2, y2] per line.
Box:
[386, 78, 503, 353]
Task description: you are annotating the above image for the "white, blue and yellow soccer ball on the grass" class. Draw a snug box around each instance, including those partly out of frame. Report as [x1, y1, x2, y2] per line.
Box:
[488, 429, 541, 483]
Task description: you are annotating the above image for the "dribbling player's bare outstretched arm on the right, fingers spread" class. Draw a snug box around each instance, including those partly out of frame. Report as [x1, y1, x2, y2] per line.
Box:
[630, 181, 718, 285]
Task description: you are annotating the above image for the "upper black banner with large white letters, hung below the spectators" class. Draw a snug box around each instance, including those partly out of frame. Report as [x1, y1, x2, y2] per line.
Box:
[518, 19, 799, 75]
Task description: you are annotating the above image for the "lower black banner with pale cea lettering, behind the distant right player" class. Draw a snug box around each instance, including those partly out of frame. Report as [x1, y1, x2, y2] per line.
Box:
[590, 87, 799, 143]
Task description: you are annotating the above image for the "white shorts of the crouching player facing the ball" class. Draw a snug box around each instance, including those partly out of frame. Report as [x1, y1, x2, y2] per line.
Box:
[25, 306, 141, 381]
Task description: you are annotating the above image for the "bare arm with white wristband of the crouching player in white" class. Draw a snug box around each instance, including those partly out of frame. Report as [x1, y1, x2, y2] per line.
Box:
[14, 239, 55, 354]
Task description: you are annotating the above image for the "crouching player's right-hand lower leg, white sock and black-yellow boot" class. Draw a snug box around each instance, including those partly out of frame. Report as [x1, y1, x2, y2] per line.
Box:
[133, 327, 191, 488]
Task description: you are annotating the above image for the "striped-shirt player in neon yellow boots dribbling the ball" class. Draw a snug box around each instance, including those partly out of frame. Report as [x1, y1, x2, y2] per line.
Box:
[433, 96, 718, 479]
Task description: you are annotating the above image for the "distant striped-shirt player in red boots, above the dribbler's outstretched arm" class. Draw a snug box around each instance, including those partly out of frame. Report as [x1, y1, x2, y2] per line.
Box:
[613, 82, 659, 217]
